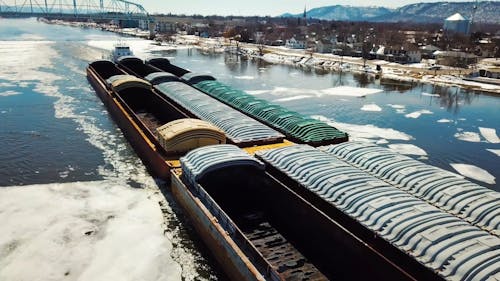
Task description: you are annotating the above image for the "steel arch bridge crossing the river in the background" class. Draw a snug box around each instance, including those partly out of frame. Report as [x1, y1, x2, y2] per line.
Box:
[0, 0, 152, 22]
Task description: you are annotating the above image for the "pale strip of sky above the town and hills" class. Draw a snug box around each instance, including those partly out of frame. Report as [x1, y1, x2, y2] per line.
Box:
[138, 0, 467, 16]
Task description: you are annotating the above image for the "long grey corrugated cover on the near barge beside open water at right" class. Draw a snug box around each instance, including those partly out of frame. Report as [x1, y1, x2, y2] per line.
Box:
[321, 142, 500, 235]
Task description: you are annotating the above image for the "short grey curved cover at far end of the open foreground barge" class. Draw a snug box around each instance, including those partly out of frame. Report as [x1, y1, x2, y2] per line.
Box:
[180, 144, 265, 186]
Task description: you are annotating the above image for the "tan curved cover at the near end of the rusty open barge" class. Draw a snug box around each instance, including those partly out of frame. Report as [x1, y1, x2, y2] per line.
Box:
[156, 118, 226, 153]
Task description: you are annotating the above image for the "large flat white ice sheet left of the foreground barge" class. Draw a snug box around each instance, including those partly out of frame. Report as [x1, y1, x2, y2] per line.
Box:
[0, 181, 181, 281]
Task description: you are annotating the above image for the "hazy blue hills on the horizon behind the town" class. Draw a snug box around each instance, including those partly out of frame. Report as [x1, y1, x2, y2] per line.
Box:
[282, 1, 500, 24]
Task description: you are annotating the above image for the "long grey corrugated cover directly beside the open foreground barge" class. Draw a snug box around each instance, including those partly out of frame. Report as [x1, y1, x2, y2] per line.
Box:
[256, 144, 500, 280]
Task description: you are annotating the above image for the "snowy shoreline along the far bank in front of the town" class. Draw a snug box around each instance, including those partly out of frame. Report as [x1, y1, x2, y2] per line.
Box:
[44, 20, 500, 95]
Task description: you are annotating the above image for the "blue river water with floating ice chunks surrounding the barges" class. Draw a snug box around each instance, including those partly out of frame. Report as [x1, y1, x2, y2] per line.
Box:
[0, 15, 500, 280]
